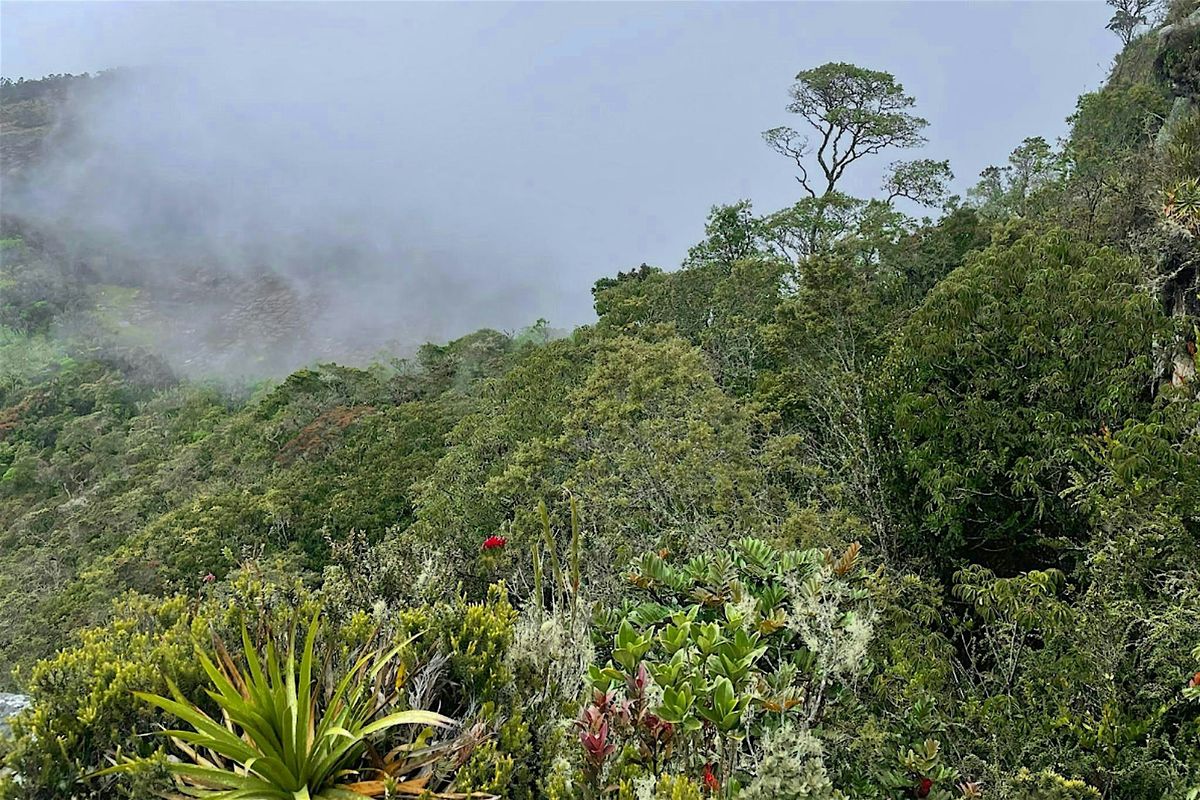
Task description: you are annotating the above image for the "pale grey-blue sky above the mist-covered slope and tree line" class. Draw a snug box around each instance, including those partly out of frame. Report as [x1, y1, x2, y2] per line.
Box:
[0, 0, 1118, 336]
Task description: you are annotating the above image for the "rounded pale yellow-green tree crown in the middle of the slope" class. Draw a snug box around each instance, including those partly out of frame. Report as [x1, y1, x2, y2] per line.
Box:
[540, 338, 755, 578]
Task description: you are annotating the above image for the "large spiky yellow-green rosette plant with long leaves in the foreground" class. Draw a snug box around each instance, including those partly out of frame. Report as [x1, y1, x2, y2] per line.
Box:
[97, 616, 482, 800]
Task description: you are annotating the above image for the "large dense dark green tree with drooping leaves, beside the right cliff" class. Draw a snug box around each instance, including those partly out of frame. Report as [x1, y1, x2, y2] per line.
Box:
[883, 233, 1164, 564]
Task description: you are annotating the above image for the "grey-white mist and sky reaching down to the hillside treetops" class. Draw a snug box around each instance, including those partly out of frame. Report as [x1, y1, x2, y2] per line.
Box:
[2, 2, 1115, 373]
